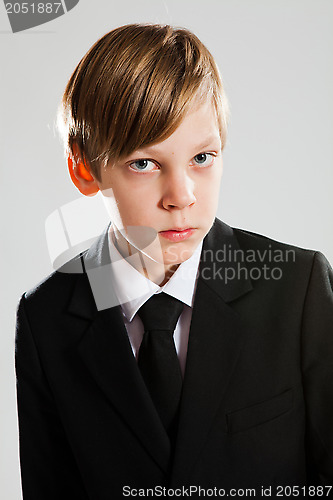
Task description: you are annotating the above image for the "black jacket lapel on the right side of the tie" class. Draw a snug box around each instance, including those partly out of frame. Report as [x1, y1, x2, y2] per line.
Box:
[172, 219, 252, 484]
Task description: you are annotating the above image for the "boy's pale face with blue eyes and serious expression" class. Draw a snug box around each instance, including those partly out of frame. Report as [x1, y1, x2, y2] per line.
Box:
[98, 102, 222, 269]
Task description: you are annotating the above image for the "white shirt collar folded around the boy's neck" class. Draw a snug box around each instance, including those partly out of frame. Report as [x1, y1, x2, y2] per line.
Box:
[108, 226, 203, 321]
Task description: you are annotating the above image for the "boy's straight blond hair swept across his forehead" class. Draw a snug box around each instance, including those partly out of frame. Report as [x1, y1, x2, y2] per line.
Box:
[60, 24, 228, 180]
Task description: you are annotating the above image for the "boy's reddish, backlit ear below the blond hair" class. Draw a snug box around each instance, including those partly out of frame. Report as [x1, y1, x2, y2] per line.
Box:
[67, 145, 99, 196]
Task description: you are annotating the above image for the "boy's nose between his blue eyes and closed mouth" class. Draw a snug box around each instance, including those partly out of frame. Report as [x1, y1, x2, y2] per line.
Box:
[162, 171, 196, 210]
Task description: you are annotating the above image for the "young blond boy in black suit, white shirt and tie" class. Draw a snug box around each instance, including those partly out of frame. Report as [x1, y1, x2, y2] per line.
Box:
[16, 25, 333, 500]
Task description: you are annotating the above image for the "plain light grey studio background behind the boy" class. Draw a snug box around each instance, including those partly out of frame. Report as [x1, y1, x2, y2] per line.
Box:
[0, 0, 333, 500]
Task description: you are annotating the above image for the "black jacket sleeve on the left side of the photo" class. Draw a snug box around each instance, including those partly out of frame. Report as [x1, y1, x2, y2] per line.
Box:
[15, 297, 88, 500]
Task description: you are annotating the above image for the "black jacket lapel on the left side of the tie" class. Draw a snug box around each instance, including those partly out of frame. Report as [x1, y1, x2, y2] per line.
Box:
[69, 230, 170, 472]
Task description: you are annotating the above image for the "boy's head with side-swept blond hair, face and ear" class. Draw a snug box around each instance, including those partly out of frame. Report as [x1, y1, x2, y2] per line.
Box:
[58, 24, 228, 280]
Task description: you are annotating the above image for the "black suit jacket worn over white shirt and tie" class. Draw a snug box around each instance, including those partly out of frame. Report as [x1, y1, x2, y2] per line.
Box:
[16, 219, 333, 500]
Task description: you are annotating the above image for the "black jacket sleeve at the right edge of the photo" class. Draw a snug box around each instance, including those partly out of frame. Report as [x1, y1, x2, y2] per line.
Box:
[301, 252, 333, 486]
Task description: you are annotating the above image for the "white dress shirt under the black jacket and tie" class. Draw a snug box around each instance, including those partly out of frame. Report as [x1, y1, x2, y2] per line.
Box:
[109, 229, 202, 376]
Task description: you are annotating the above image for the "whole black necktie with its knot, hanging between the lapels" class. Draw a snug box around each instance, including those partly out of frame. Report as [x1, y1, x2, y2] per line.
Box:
[138, 292, 184, 437]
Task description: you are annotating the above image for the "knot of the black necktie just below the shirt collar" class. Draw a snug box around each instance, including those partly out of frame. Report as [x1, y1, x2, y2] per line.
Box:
[138, 292, 184, 332]
